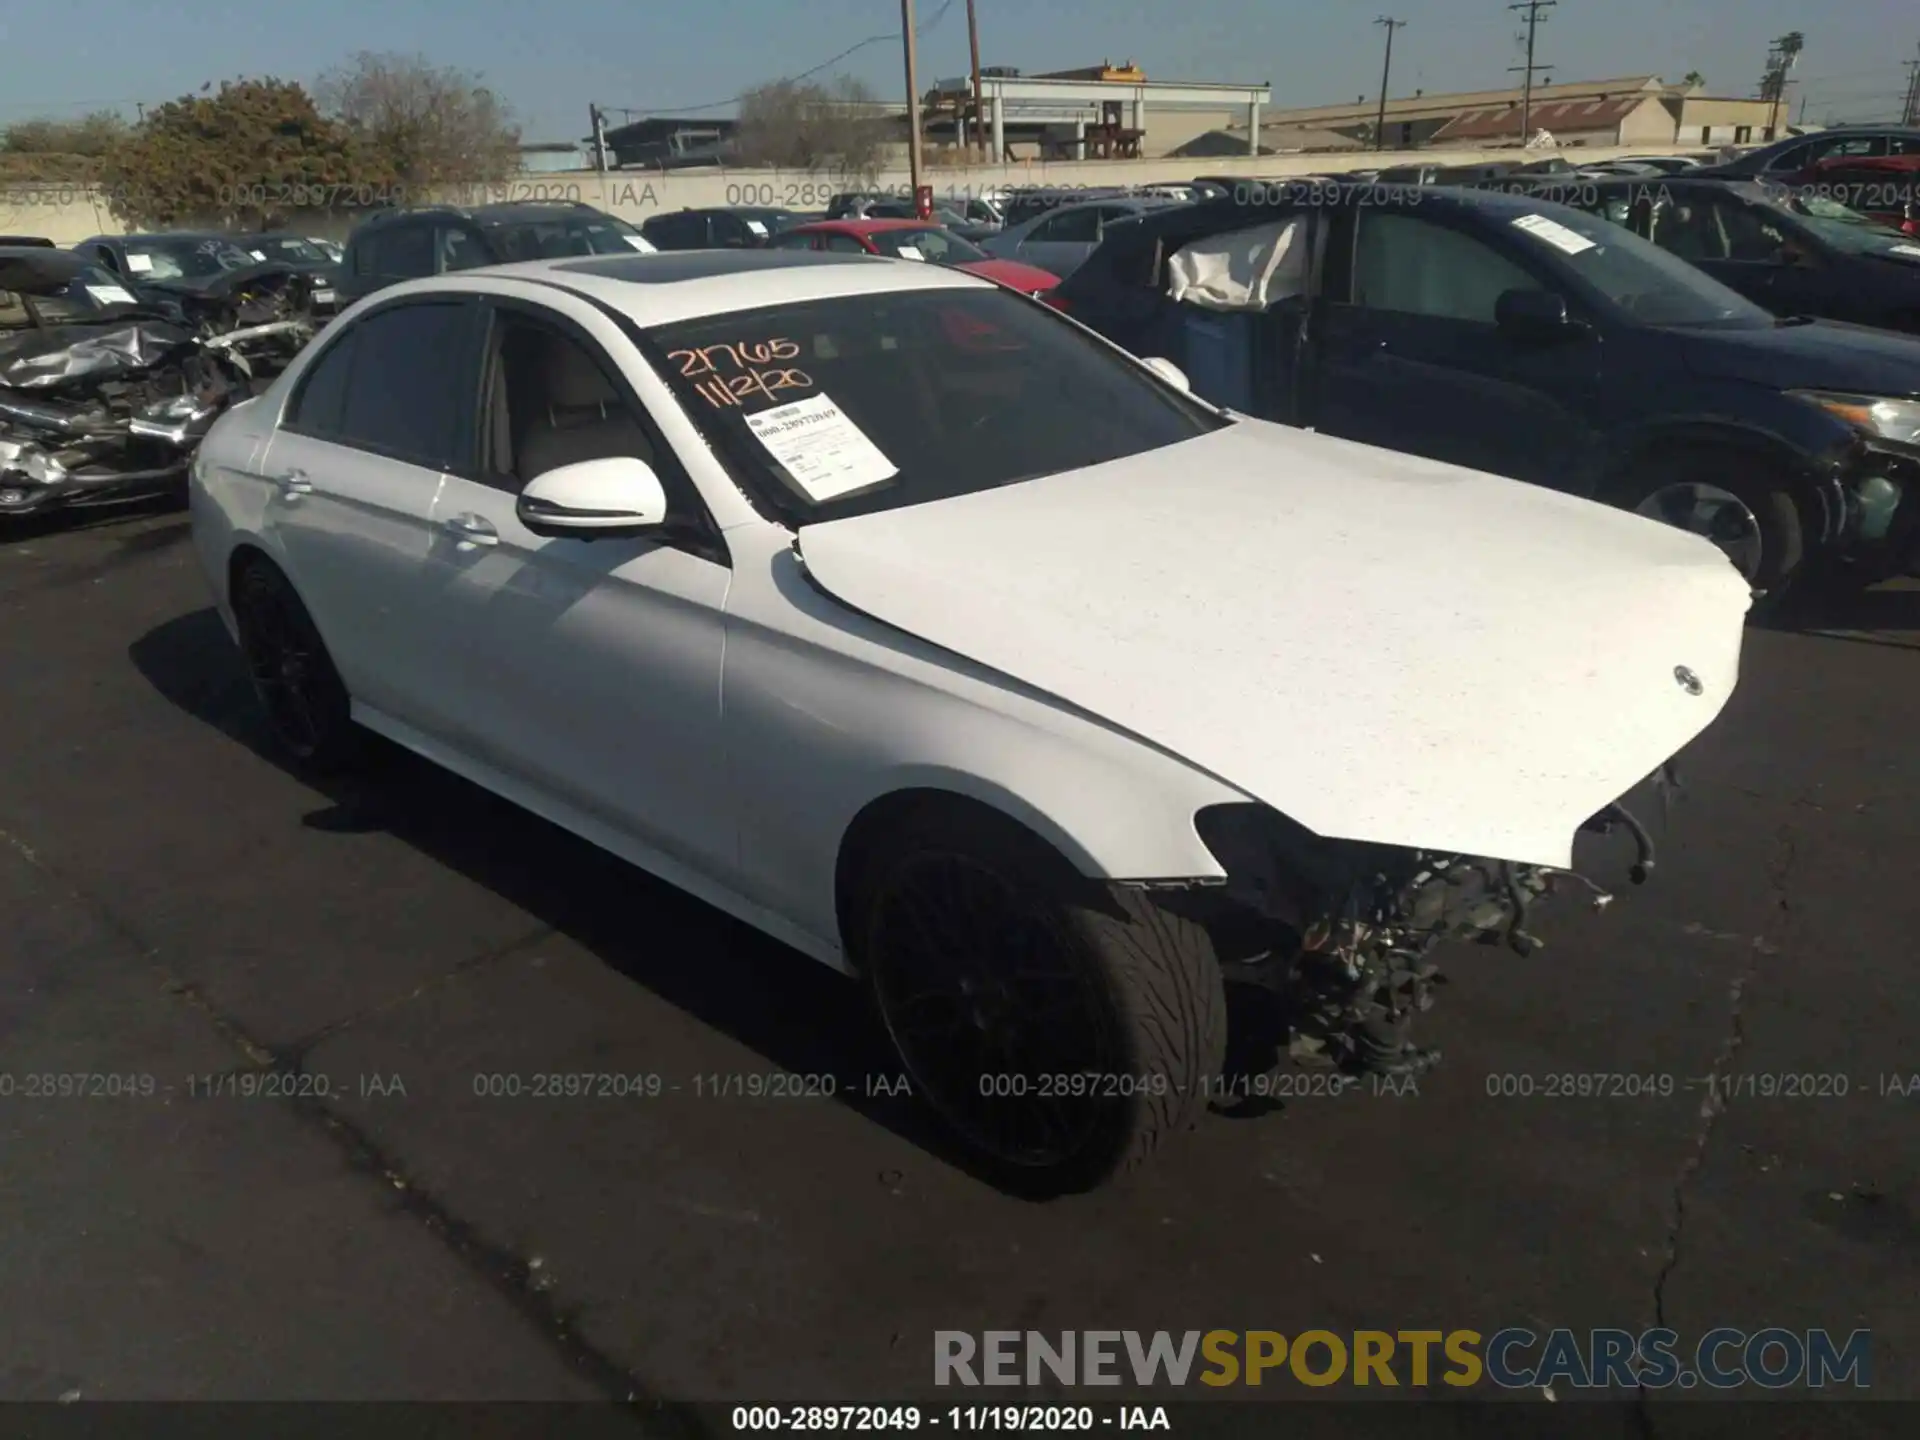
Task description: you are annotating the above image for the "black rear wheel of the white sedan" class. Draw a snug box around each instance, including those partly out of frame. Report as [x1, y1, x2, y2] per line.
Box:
[232, 559, 361, 774]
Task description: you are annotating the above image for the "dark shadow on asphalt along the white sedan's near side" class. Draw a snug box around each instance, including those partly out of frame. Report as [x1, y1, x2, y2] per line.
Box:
[129, 609, 1043, 1198]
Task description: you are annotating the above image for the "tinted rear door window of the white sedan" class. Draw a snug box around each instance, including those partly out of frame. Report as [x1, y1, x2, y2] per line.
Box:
[330, 301, 472, 468]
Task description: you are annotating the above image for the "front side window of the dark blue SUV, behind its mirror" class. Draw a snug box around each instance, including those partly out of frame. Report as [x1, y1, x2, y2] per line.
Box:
[1352, 209, 1542, 324]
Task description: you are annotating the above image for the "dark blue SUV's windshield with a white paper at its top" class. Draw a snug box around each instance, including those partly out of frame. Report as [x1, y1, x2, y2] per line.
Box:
[1501, 205, 1774, 330]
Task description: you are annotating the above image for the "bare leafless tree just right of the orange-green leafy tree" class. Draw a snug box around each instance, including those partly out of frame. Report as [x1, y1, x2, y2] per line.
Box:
[315, 50, 520, 192]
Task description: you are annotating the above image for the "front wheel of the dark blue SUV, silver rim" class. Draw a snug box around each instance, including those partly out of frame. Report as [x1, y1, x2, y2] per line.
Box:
[1615, 451, 1807, 603]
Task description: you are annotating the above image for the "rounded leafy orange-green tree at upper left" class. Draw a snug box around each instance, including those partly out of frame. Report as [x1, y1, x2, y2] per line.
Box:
[100, 79, 394, 228]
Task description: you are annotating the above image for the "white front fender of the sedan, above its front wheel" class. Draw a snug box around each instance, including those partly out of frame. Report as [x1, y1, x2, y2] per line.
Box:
[722, 532, 1246, 960]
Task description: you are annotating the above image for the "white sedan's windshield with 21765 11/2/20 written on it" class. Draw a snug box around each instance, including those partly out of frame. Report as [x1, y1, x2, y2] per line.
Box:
[645, 286, 1227, 524]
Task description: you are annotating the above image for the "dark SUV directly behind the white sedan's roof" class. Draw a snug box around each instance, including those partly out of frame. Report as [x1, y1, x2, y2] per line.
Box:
[340, 200, 653, 305]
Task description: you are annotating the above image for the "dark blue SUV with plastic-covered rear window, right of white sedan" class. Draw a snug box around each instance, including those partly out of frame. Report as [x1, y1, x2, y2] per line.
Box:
[1046, 184, 1920, 605]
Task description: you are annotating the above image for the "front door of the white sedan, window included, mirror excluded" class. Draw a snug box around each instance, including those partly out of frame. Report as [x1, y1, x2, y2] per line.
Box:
[426, 296, 739, 879]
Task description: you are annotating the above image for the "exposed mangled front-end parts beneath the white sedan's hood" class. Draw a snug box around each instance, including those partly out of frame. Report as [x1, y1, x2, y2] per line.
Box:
[1164, 779, 1678, 1075]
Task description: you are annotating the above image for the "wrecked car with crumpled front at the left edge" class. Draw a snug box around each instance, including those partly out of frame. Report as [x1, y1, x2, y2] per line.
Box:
[0, 248, 250, 526]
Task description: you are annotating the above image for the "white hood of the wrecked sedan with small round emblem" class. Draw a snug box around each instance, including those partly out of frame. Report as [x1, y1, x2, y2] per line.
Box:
[797, 420, 1751, 868]
